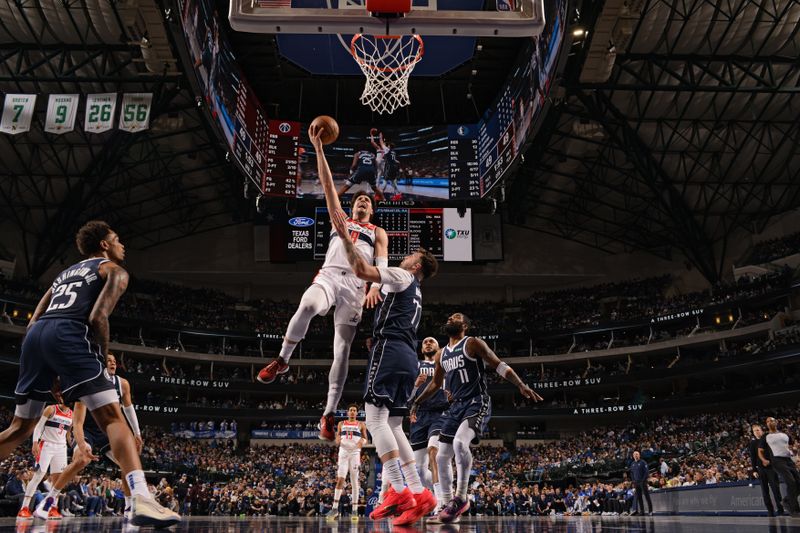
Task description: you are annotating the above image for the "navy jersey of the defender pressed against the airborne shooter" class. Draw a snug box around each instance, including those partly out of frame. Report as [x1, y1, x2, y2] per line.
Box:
[373, 267, 422, 352]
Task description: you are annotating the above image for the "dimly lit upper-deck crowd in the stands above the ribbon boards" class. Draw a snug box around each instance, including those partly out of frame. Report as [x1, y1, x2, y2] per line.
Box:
[0, 270, 791, 350]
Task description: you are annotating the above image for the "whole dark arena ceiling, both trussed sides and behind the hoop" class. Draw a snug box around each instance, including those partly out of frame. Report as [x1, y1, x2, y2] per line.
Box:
[0, 0, 800, 280]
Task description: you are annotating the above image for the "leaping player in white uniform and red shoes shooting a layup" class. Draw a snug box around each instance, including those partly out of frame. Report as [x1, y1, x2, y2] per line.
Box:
[258, 137, 389, 440]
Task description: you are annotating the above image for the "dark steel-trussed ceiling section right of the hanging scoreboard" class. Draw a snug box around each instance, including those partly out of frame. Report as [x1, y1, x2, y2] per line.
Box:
[509, 0, 800, 281]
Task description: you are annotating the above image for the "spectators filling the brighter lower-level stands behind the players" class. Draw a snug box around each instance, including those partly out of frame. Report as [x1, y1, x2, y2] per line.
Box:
[0, 408, 800, 516]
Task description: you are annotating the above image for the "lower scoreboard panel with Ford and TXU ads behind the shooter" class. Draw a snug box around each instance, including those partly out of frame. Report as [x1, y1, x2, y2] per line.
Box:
[270, 207, 472, 261]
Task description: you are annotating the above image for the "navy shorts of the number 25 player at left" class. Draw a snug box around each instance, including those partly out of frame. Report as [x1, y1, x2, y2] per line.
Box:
[14, 318, 114, 408]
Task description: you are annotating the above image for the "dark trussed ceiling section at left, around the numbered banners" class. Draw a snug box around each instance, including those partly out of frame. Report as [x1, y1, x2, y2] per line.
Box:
[0, 0, 243, 276]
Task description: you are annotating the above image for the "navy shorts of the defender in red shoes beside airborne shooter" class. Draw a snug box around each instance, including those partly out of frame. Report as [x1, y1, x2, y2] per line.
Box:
[364, 339, 419, 416]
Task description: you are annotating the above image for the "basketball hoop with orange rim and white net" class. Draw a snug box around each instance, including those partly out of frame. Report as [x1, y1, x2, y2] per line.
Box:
[350, 33, 425, 114]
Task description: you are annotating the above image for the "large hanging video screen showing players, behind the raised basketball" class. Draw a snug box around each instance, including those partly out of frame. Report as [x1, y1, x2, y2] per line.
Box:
[302, 126, 450, 201]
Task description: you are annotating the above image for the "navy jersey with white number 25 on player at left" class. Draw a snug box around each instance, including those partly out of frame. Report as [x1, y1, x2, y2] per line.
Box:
[41, 257, 108, 323]
